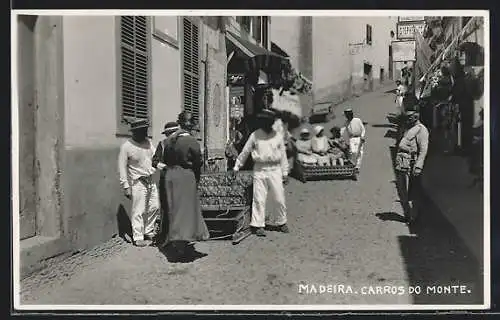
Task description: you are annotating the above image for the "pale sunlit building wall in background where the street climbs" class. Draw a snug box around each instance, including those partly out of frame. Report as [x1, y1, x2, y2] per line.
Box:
[271, 16, 397, 115]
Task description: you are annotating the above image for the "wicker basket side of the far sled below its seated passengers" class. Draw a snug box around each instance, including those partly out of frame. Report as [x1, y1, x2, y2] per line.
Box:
[293, 160, 357, 183]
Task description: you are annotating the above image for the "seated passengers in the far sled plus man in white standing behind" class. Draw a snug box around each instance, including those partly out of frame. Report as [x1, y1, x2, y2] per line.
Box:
[296, 108, 366, 173]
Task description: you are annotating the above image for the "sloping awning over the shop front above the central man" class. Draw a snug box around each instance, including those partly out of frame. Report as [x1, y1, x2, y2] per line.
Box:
[226, 31, 290, 72]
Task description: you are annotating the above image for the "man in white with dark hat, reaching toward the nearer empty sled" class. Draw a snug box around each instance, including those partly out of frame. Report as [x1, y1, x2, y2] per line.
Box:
[233, 110, 289, 237]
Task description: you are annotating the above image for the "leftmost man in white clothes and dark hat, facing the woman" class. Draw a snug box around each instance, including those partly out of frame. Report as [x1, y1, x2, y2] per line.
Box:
[118, 120, 159, 247]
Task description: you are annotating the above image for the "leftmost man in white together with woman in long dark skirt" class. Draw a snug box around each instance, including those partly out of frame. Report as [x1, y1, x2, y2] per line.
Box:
[118, 113, 209, 258]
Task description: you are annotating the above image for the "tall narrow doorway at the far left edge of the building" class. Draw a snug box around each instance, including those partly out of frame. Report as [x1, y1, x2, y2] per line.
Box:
[17, 16, 37, 240]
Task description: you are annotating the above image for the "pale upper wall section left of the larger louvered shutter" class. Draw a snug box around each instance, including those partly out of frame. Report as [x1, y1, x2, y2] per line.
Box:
[63, 16, 117, 147]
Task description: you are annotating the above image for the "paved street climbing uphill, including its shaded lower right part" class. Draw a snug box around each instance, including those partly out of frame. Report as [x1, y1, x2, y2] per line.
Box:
[22, 86, 482, 304]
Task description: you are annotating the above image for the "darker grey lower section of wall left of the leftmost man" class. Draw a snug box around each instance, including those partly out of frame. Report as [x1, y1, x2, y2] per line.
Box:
[65, 146, 130, 250]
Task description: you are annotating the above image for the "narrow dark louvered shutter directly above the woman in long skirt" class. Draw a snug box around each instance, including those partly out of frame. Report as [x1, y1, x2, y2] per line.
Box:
[182, 18, 200, 121]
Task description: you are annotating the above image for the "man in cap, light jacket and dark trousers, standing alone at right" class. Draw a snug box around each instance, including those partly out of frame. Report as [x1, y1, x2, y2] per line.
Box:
[396, 111, 429, 224]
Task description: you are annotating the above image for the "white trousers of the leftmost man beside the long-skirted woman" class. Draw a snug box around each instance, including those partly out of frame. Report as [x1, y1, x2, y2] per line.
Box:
[129, 181, 160, 241]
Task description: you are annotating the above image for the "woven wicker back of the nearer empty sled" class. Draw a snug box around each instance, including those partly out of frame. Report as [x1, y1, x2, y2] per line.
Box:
[198, 171, 253, 210]
